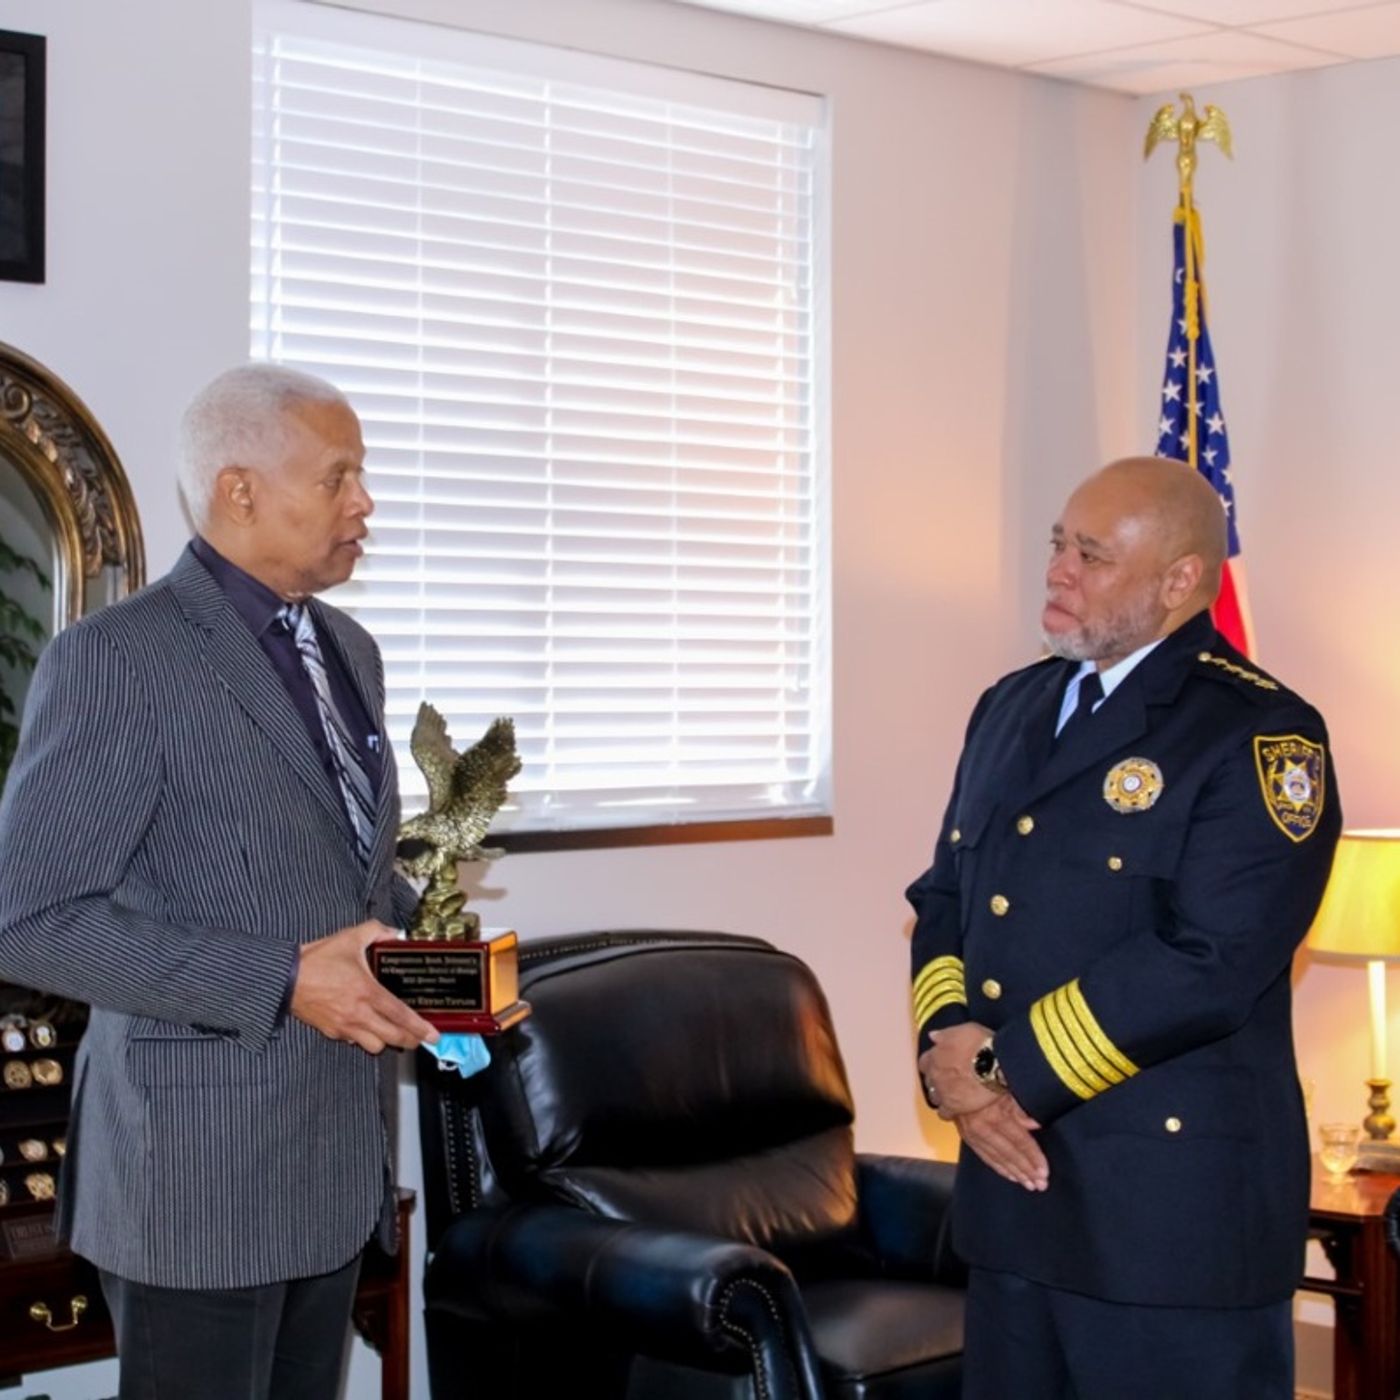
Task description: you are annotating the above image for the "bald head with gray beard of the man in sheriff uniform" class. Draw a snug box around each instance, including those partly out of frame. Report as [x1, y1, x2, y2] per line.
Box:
[1042, 456, 1228, 668]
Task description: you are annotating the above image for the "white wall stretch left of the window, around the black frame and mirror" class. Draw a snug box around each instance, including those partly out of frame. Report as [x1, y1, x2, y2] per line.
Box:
[0, 0, 252, 575]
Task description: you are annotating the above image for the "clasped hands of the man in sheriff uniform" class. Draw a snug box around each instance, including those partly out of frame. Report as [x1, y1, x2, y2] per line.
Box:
[918, 1021, 1050, 1191]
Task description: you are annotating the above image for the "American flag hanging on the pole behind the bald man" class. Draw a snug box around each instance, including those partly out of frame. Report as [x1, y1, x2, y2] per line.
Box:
[1156, 209, 1254, 657]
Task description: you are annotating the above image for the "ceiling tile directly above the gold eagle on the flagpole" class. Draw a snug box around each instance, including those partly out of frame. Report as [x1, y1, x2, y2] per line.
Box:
[1026, 29, 1340, 94]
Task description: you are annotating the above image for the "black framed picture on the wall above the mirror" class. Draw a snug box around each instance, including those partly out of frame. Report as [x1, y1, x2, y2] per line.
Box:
[0, 29, 45, 281]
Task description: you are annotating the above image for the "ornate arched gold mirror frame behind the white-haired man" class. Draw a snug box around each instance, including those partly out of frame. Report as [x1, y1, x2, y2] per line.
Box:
[0, 343, 146, 626]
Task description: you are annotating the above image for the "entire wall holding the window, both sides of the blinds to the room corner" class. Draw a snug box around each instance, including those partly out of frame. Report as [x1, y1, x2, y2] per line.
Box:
[0, 0, 1141, 1400]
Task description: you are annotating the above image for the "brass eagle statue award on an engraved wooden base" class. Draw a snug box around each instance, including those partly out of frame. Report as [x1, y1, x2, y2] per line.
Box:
[370, 701, 529, 1035]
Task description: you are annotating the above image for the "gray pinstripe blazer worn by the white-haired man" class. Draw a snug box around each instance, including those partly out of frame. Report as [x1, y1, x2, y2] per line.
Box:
[0, 552, 412, 1288]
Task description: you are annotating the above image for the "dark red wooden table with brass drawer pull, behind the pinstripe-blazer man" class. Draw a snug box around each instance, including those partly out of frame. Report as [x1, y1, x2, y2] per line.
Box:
[0, 1189, 417, 1400]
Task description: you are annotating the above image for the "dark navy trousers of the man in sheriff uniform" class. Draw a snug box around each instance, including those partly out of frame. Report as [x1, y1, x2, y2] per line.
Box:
[963, 1268, 1294, 1400]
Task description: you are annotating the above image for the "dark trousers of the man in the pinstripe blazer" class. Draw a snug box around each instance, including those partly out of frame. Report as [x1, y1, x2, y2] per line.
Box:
[101, 1259, 360, 1400]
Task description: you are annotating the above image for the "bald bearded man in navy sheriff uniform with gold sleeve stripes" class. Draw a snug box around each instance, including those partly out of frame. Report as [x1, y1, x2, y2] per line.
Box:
[909, 458, 1341, 1400]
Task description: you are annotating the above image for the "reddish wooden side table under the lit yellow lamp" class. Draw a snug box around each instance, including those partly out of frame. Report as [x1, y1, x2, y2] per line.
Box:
[1302, 1159, 1400, 1400]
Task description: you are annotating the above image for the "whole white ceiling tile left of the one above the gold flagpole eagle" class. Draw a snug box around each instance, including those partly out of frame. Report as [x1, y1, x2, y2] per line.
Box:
[827, 0, 1207, 67]
